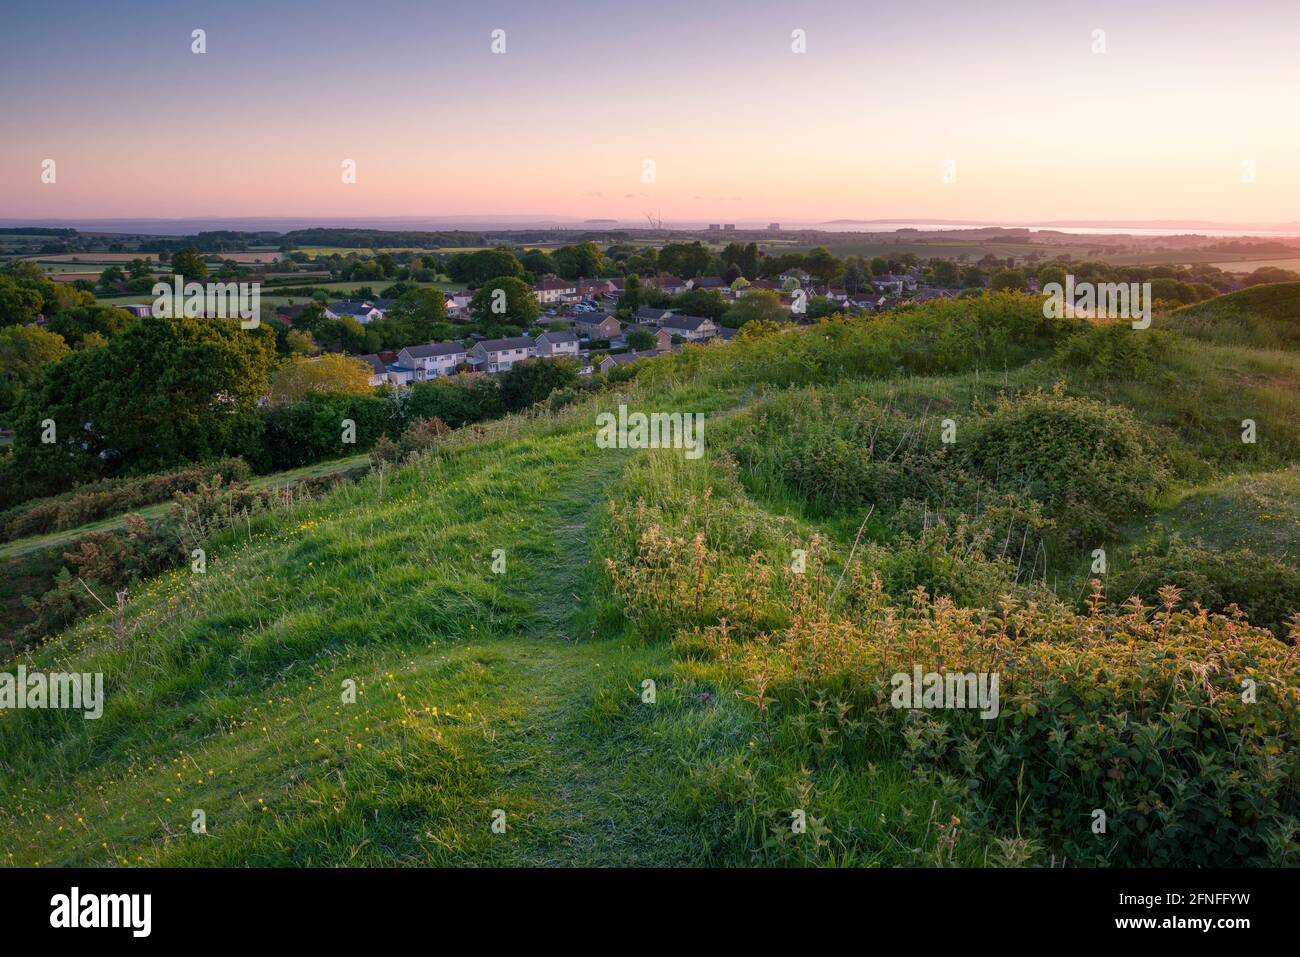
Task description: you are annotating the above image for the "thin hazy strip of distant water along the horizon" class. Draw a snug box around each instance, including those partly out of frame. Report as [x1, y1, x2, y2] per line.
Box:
[0, 216, 1300, 238]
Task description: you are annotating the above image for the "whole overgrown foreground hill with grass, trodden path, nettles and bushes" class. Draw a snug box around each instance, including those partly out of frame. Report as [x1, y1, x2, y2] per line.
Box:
[0, 296, 1300, 866]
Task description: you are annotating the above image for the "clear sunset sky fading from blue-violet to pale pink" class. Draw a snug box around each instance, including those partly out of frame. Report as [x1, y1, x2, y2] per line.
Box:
[0, 0, 1300, 224]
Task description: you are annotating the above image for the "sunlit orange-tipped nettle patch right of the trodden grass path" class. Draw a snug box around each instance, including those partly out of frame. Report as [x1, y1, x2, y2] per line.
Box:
[606, 470, 1300, 866]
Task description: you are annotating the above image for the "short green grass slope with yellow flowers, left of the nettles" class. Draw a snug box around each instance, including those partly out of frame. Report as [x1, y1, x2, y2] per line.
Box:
[0, 433, 722, 863]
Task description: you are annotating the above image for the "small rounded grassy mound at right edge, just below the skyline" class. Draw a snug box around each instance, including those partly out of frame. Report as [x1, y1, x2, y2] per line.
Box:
[1154, 282, 1300, 351]
